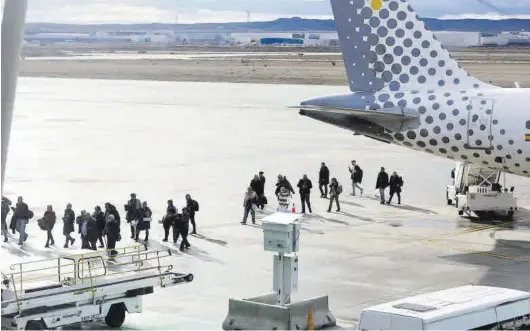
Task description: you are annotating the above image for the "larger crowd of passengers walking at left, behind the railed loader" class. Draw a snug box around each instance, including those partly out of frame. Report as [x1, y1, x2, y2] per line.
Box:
[2, 193, 199, 255]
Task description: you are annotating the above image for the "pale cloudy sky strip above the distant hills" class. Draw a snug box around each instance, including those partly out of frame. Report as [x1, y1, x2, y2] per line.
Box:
[27, 0, 530, 24]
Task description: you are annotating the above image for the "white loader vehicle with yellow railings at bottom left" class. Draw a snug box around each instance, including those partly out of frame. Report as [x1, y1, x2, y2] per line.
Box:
[2, 246, 193, 330]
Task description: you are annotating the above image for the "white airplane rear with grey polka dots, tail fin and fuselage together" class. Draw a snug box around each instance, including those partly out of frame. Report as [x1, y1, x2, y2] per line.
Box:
[296, 0, 530, 177]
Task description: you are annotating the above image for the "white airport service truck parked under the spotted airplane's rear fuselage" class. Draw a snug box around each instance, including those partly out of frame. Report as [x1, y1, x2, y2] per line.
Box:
[446, 162, 517, 219]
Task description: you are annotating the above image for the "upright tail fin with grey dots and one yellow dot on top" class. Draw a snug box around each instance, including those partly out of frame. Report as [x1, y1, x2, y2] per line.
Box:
[331, 0, 488, 92]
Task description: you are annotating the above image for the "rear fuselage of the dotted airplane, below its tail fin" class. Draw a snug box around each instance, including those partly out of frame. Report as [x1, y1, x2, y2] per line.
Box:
[301, 88, 530, 177]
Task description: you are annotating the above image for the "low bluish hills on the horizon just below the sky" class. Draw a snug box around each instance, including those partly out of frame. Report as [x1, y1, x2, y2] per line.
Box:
[26, 17, 530, 33]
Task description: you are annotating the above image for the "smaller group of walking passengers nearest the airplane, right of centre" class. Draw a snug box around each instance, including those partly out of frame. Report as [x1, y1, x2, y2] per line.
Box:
[241, 160, 403, 224]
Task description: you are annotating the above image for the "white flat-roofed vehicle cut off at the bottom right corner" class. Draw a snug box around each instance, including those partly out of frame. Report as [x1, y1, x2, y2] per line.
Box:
[357, 285, 530, 330]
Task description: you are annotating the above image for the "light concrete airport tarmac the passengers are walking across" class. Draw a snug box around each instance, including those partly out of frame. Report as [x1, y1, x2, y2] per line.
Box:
[0, 78, 530, 329]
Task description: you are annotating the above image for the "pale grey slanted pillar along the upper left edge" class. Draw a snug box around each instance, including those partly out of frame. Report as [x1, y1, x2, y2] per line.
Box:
[1, 0, 28, 192]
